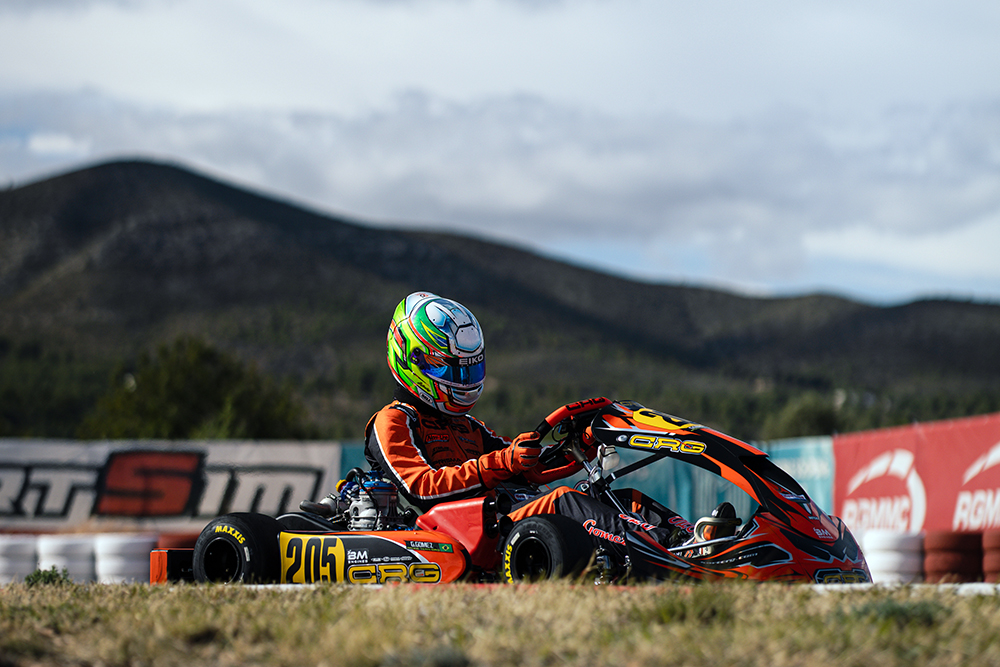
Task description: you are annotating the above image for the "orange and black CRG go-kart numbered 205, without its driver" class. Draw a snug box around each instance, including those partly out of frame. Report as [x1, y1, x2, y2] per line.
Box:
[150, 398, 871, 584]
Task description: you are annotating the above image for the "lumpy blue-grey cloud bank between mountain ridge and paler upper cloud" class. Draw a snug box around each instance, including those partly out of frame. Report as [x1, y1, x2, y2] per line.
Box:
[0, 92, 1000, 302]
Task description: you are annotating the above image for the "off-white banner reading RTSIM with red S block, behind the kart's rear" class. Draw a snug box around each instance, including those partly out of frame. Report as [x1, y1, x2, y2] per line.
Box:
[0, 438, 343, 531]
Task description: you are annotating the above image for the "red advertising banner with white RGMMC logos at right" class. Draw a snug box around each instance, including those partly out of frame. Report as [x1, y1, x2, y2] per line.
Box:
[833, 414, 1000, 534]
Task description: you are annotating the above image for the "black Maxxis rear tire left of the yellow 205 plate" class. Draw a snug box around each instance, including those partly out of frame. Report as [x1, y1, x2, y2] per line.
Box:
[192, 512, 281, 584]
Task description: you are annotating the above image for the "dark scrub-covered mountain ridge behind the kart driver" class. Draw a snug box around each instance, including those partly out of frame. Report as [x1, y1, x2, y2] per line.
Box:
[0, 162, 1000, 436]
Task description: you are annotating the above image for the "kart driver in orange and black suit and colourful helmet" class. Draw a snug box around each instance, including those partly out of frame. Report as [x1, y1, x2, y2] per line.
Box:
[365, 292, 692, 547]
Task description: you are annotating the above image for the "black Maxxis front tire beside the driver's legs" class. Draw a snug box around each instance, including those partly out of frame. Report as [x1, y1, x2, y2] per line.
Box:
[503, 514, 594, 583]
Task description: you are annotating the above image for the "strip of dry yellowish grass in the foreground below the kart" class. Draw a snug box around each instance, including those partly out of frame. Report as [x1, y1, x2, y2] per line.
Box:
[0, 584, 1000, 667]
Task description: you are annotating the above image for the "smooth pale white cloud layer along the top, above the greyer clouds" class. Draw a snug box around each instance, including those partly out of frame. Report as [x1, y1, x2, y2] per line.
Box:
[0, 0, 1000, 120]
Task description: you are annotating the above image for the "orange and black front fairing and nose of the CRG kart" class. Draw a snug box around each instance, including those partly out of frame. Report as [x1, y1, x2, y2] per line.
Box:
[587, 402, 871, 583]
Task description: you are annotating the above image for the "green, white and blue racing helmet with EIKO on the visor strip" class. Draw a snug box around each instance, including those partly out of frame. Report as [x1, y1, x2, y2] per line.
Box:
[386, 292, 486, 415]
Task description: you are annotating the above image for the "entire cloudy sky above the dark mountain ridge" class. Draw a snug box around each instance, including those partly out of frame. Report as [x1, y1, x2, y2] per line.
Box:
[0, 0, 1000, 304]
